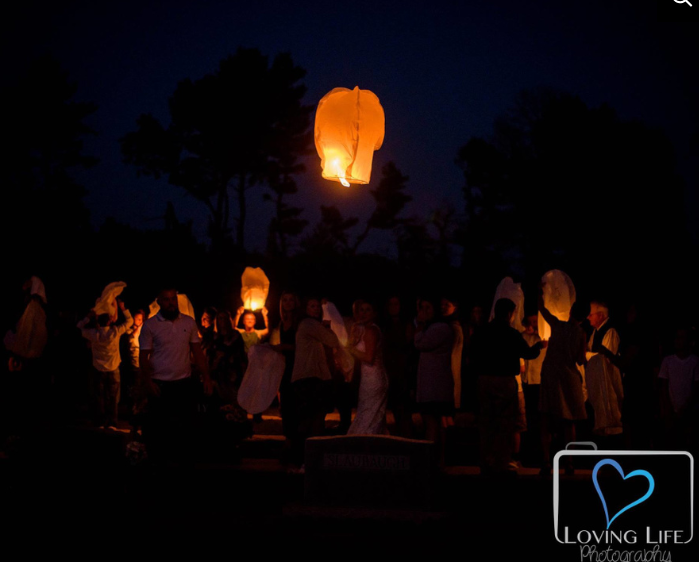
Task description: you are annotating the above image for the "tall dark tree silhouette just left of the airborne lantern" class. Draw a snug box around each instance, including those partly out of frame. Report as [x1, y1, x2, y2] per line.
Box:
[122, 48, 311, 249]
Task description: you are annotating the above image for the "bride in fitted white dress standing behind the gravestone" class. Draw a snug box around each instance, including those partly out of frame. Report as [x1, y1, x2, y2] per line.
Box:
[347, 302, 388, 435]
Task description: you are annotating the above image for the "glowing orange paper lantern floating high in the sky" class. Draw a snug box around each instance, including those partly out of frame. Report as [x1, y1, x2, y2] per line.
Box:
[315, 86, 385, 187]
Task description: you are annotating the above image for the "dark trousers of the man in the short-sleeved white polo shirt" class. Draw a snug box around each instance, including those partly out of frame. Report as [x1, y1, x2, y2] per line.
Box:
[143, 377, 196, 465]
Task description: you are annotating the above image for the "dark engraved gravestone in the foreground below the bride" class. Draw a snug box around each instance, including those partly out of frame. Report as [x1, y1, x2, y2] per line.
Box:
[304, 435, 434, 509]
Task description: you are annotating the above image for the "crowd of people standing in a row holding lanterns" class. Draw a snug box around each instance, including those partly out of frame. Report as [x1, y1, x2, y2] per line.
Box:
[1, 277, 699, 475]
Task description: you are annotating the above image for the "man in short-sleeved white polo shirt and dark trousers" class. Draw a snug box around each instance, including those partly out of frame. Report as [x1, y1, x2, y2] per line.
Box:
[139, 289, 212, 462]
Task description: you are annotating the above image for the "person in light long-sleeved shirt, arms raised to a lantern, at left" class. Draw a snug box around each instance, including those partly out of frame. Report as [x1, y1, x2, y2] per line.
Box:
[78, 300, 133, 429]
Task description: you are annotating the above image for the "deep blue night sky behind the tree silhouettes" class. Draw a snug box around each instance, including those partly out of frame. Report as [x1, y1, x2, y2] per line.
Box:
[5, 0, 699, 253]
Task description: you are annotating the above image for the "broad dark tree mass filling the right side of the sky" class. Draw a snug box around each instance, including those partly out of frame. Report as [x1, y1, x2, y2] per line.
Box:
[456, 90, 686, 294]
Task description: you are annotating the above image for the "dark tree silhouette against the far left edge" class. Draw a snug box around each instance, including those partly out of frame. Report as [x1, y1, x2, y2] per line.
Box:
[0, 57, 97, 304]
